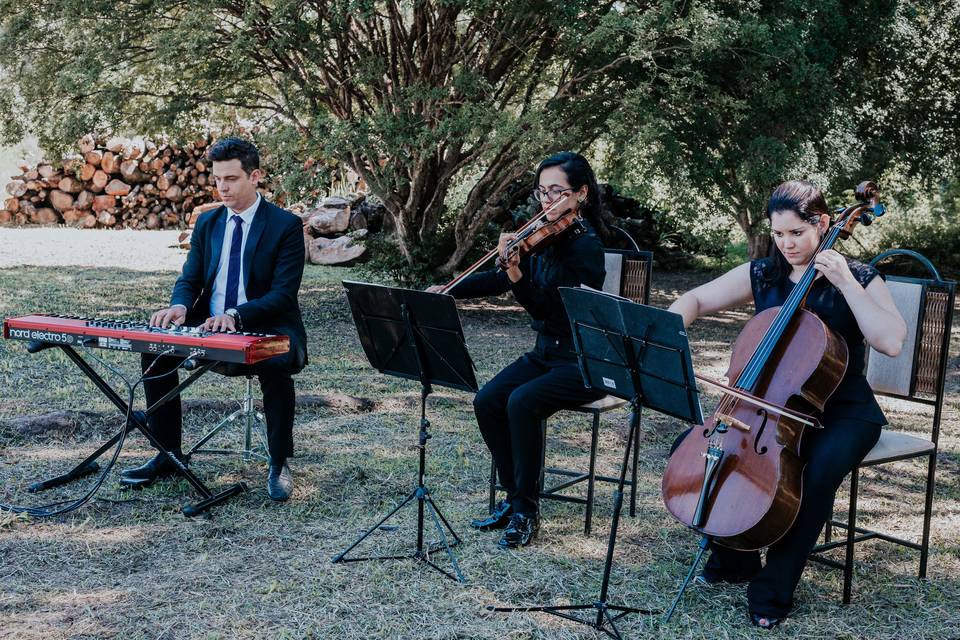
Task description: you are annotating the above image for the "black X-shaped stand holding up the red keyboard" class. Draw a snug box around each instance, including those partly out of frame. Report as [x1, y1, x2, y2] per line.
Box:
[27, 342, 247, 516]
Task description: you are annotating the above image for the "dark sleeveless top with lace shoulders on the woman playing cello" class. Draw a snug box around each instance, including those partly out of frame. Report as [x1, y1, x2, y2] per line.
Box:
[750, 258, 887, 426]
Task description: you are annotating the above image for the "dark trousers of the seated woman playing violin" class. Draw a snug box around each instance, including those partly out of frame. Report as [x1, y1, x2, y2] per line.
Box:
[473, 335, 606, 515]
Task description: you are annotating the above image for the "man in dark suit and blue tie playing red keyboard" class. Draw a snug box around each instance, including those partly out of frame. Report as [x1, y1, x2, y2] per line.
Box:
[120, 138, 307, 501]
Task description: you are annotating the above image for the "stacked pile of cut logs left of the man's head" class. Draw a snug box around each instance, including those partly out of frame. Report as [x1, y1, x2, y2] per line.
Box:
[0, 136, 215, 229]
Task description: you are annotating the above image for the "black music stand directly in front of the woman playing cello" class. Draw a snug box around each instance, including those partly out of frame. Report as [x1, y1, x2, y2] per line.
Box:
[487, 287, 703, 640]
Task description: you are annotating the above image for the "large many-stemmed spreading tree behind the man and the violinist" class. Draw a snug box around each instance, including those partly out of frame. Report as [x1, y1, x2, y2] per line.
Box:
[0, 0, 639, 272]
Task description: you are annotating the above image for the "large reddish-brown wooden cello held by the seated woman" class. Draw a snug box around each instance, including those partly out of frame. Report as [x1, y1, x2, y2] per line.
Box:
[661, 182, 884, 551]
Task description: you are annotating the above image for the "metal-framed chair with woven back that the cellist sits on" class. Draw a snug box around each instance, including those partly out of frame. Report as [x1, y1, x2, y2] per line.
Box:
[811, 249, 956, 604]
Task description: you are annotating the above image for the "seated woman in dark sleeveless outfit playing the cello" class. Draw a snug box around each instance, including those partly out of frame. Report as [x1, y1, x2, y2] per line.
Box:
[670, 181, 906, 629]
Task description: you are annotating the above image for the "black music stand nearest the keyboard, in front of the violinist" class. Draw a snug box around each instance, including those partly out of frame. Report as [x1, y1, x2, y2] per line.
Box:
[332, 280, 477, 582]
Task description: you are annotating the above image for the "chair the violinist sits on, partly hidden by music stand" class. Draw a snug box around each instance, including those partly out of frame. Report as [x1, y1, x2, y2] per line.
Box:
[490, 249, 653, 534]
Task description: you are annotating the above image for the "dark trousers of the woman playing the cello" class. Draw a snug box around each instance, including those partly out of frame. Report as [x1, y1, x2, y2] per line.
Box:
[676, 418, 880, 618]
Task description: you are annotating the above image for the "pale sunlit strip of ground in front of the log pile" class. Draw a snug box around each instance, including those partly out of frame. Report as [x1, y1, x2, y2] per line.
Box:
[0, 228, 187, 271]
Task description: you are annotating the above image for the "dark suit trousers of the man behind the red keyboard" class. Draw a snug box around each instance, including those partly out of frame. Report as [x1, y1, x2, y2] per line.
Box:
[141, 351, 296, 460]
